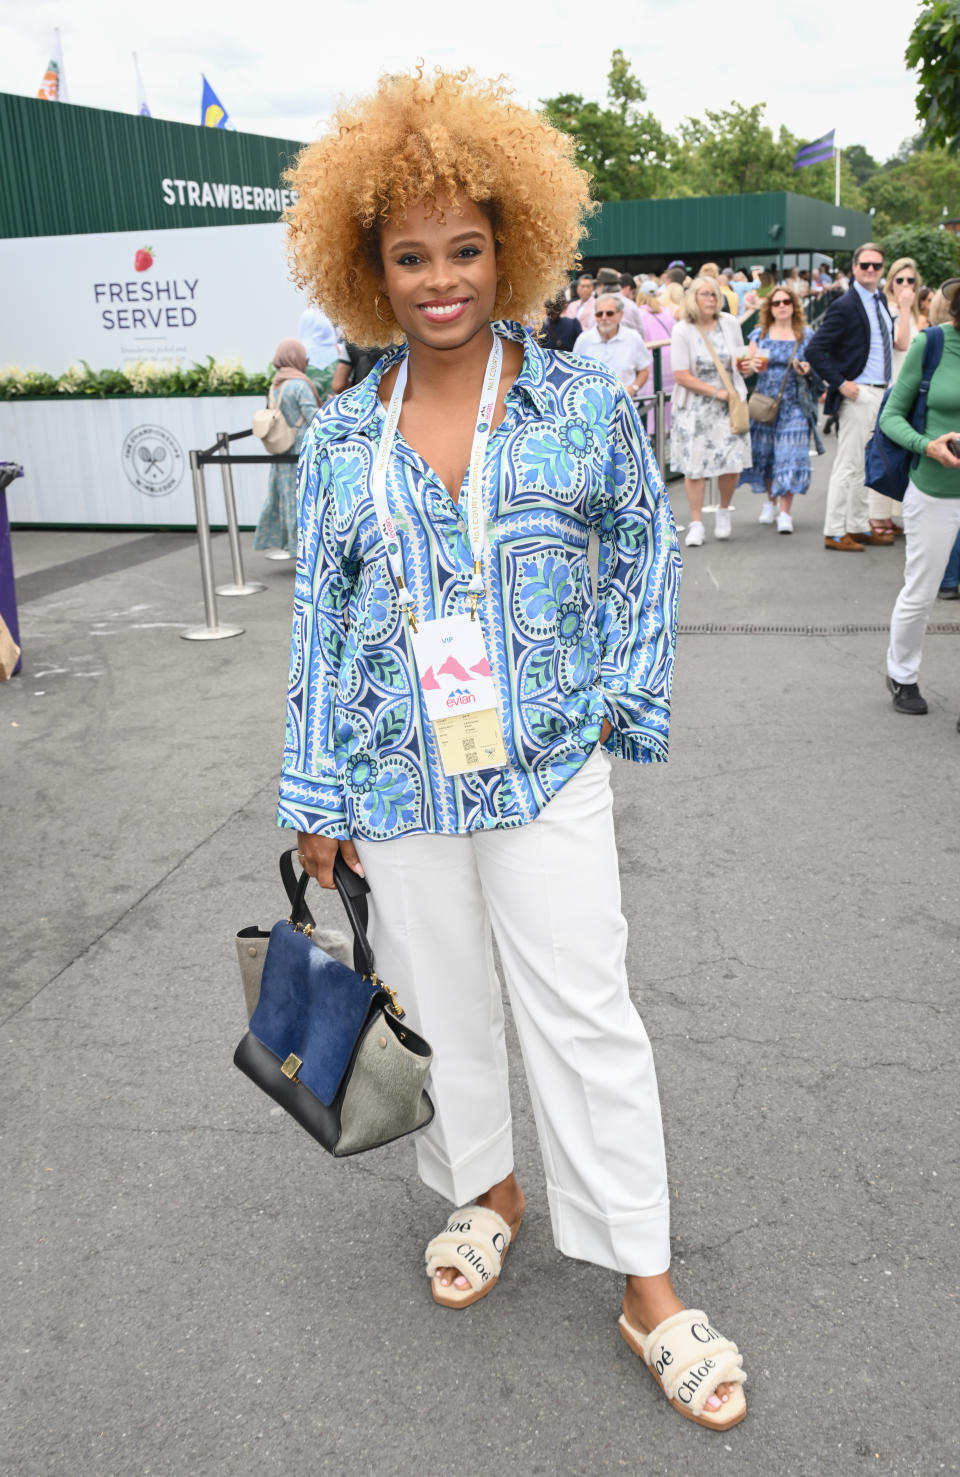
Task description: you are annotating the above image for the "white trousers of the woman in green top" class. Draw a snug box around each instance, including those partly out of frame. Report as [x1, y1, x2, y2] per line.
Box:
[886, 482, 960, 682]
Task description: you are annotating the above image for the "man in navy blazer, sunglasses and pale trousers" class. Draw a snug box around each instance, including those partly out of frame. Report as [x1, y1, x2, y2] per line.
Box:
[806, 241, 894, 554]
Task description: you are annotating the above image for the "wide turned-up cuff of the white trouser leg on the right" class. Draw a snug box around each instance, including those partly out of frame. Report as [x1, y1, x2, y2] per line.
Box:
[546, 1185, 671, 1278]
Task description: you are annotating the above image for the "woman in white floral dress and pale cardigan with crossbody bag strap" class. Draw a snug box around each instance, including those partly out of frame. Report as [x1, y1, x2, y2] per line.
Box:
[671, 278, 750, 548]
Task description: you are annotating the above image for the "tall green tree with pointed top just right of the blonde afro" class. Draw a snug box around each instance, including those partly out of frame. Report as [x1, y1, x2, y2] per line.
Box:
[541, 49, 671, 199]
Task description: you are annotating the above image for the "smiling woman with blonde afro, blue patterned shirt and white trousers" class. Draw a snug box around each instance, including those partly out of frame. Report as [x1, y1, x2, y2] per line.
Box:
[279, 72, 746, 1430]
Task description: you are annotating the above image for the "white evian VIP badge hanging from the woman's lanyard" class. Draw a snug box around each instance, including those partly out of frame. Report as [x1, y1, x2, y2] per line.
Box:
[411, 616, 507, 774]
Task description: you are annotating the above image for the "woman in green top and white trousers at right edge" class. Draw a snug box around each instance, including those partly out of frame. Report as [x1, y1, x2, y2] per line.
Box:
[880, 278, 960, 720]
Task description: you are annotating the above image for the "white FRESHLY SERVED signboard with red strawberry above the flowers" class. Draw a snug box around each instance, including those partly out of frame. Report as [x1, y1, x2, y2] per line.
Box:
[0, 222, 306, 375]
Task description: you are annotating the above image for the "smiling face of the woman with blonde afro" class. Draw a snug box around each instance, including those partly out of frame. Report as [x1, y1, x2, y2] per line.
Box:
[380, 195, 496, 349]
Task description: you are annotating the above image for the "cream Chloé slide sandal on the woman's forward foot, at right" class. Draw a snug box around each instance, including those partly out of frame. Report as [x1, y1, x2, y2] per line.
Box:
[620, 1307, 747, 1431]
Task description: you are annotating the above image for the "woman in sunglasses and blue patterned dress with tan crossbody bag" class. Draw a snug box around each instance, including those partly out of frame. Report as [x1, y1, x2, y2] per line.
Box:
[740, 287, 815, 533]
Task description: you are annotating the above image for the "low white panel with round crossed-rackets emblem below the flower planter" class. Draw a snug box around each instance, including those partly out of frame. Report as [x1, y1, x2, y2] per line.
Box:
[0, 395, 280, 529]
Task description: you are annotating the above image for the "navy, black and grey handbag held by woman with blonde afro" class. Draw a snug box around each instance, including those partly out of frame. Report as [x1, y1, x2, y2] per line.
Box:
[233, 852, 433, 1158]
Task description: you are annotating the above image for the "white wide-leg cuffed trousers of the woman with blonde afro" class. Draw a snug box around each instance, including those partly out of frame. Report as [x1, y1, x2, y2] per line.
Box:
[351, 749, 671, 1276]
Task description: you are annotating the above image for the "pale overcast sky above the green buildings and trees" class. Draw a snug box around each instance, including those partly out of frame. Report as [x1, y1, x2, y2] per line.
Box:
[0, 0, 917, 161]
